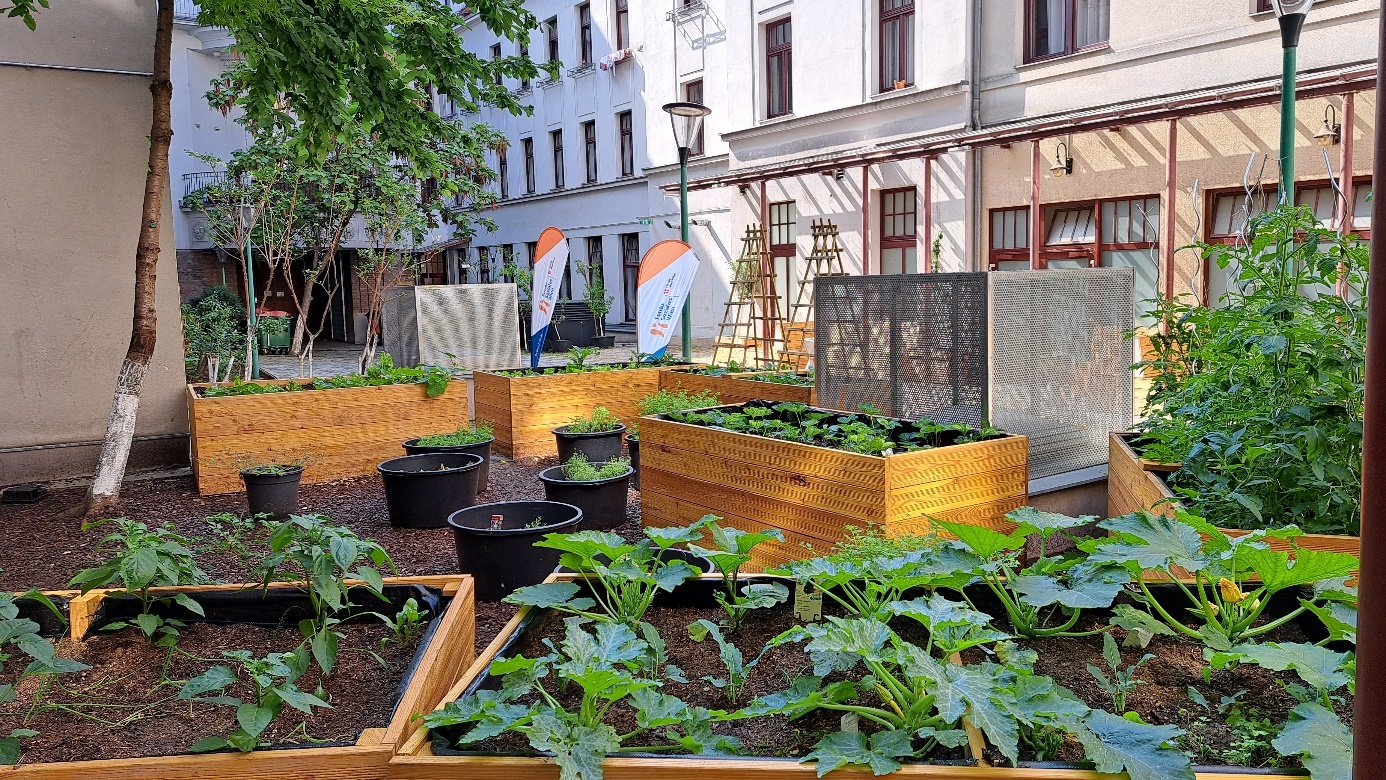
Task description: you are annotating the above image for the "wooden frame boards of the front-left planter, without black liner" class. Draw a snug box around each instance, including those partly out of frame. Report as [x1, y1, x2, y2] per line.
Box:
[0, 575, 477, 780]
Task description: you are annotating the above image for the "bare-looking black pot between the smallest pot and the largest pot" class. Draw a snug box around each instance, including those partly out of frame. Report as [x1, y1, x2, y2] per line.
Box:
[376, 453, 482, 528]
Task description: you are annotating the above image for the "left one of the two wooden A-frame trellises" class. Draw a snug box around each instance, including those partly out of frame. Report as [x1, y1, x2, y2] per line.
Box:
[712, 224, 784, 369]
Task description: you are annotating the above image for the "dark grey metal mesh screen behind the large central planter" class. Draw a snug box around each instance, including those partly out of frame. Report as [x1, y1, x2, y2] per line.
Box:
[814, 273, 987, 425]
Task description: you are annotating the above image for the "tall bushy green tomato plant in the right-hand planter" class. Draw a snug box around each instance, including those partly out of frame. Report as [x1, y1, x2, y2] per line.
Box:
[1137, 206, 1367, 535]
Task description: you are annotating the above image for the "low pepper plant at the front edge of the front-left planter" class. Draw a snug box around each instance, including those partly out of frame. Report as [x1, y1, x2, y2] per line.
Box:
[177, 646, 331, 752]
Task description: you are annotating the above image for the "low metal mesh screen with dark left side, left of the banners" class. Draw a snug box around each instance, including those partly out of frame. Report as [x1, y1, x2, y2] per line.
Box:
[384, 284, 520, 370]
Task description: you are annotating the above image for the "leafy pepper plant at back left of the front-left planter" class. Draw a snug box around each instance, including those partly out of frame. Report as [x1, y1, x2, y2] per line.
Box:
[69, 517, 207, 646]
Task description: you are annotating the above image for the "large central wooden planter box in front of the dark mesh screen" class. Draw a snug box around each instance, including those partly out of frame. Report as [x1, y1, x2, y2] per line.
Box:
[640, 417, 1030, 569]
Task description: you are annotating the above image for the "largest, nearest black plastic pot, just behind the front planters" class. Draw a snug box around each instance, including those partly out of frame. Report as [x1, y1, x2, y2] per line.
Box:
[448, 502, 582, 601]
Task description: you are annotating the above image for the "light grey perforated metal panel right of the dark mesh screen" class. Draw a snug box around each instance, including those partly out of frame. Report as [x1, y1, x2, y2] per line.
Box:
[990, 267, 1135, 479]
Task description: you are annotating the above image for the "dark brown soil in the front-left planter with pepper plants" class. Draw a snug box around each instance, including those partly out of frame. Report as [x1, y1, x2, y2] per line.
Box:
[0, 623, 417, 763]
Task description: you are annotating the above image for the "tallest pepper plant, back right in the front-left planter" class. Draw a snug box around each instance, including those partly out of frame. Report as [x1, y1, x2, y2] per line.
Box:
[255, 514, 395, 675]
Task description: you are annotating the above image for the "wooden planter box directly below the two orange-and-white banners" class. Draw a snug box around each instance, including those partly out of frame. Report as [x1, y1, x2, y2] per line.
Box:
[473, 367, 668, 459]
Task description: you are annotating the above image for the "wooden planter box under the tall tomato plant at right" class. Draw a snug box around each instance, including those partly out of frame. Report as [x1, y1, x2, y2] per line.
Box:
[1107, 432, 1361, 556]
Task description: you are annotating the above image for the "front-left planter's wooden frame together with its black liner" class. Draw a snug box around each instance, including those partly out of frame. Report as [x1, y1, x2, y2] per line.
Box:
[0, 576, 475, 780]
